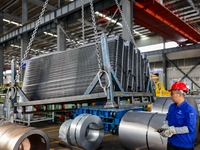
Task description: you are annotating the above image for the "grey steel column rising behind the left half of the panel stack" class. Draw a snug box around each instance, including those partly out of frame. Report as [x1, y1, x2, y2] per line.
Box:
[57, 22, 66, 51]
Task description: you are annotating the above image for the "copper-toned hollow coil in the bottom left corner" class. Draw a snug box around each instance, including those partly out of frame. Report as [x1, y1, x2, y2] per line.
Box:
[0, 123, 50, 150]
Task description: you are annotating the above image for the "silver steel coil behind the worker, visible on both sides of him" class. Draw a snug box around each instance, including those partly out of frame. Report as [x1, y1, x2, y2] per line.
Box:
[151, 96, 199, 138]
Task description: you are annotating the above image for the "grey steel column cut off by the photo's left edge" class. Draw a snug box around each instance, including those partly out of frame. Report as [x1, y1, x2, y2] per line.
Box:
[0, 15, 4, 83]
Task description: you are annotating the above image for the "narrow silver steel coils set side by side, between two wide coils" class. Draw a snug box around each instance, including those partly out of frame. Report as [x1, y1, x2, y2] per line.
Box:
[59, 114, 104, 150]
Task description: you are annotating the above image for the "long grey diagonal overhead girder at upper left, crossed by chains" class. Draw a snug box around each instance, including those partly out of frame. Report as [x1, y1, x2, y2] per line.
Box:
[0, 0, 115, 44]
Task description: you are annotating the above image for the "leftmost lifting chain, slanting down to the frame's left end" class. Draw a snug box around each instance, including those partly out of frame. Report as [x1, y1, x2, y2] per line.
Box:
[15, 0, 49, 82]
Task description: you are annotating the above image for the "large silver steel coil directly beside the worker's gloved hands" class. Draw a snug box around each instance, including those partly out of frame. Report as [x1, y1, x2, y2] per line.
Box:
[119, 111, 167, 150]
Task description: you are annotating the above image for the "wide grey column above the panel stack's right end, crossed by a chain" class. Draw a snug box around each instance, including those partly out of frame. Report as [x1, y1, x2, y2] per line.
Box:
[121, 0, 133, 41]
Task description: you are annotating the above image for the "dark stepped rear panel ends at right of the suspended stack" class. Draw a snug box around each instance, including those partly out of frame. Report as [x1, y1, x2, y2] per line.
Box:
[123, 41, 149, 92]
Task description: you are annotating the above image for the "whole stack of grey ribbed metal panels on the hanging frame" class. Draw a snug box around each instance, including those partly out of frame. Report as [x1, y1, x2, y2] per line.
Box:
[22, 36, 150, 100]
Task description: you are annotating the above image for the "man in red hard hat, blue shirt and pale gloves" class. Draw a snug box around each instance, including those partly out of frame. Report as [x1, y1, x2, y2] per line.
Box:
[160, 82, 198, 150]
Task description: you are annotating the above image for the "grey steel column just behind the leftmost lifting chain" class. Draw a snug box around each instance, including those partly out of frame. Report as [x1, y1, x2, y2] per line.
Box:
[19, 0, 28, 81]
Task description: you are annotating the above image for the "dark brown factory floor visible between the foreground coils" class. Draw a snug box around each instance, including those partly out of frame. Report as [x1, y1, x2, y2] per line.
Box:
[31, 122, 200, 150]
